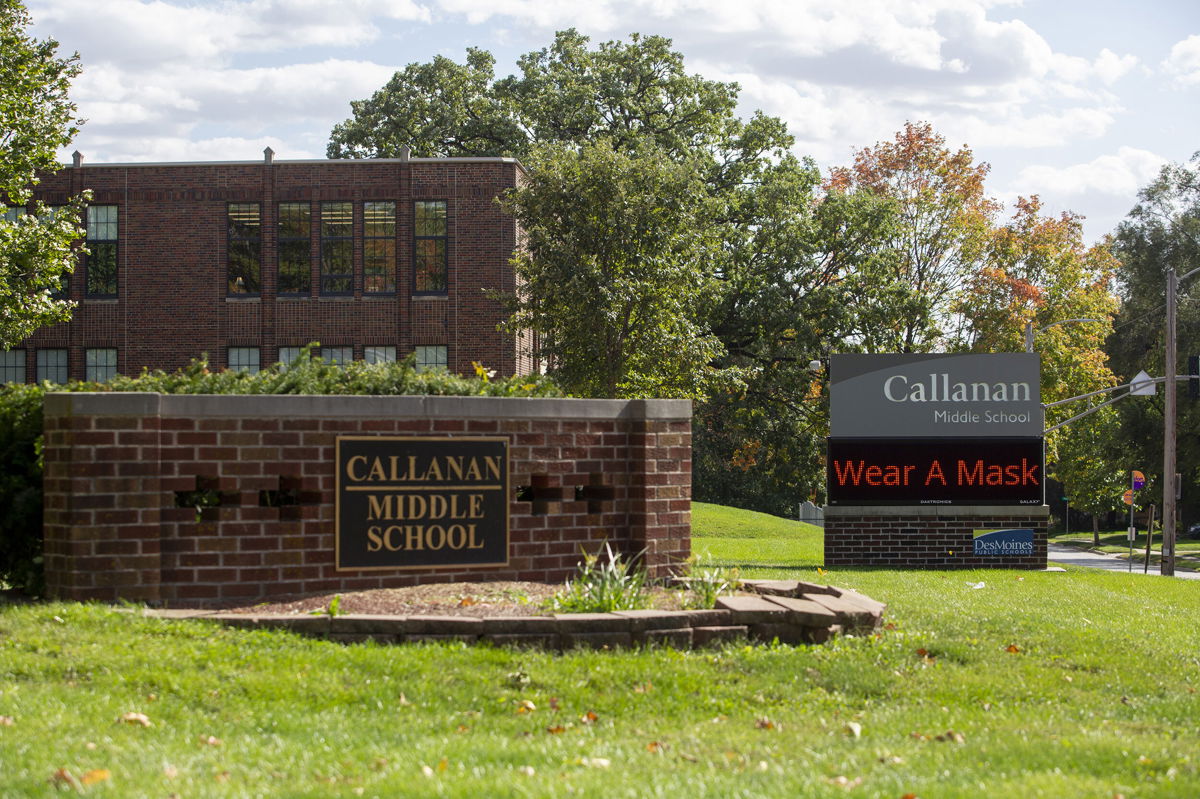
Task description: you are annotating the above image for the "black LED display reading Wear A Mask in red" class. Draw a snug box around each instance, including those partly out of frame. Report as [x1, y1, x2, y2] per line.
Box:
[826, 438, 1045, 505]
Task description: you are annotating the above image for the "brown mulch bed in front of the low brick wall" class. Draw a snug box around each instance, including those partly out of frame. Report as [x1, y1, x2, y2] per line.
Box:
[213, 582, 683, 617]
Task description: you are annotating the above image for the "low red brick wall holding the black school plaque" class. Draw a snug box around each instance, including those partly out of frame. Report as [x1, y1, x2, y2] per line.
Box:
[44, 394, 691, 606]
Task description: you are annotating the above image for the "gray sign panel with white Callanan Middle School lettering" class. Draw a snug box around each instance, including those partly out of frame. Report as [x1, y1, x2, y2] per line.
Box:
[829, 353, 1045, 438]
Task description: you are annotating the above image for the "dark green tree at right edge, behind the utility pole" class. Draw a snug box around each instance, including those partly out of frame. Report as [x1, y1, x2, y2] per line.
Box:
[1109, 154, 1200, 522]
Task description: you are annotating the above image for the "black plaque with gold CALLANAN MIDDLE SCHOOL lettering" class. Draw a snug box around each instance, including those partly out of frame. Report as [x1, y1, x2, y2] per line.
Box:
[335, 435, 509, 571]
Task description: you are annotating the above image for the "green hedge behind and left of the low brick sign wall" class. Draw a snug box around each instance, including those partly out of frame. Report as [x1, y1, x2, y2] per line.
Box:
[0, 343, 563, 595]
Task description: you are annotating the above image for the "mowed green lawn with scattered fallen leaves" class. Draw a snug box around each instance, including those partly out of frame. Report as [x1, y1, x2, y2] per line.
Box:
[0, 505, 1200, 799]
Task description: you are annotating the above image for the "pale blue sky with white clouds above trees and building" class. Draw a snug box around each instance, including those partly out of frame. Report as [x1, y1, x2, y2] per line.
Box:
[26, 0, 1200, 239]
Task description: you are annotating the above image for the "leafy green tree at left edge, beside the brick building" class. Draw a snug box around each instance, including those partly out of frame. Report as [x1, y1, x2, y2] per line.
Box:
[0, 0, 83, 348]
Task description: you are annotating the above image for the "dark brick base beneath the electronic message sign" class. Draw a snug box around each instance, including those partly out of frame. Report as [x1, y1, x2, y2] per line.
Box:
[824, 505, 1050, 569]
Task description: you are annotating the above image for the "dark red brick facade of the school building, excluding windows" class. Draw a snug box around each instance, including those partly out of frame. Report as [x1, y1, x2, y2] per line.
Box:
[18, 158, 521, 382]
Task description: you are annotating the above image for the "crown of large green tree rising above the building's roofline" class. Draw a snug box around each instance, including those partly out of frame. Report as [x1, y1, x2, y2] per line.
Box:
[328, 29, 791, 179]
